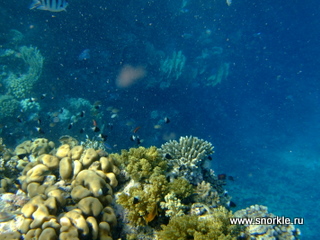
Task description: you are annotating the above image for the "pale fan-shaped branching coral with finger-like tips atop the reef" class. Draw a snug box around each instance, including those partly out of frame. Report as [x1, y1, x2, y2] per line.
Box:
[159, 136, 213, 184]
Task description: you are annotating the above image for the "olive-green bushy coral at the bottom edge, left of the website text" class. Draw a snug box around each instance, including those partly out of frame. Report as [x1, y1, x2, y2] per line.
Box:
[157, 207, 245, 240]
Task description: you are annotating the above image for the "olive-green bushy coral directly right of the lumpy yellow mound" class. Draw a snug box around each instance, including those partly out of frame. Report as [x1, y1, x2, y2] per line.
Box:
[112, 147, 169, 226]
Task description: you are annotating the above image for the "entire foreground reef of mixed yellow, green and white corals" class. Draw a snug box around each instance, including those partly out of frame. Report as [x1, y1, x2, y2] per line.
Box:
[0, 136, 299, 240]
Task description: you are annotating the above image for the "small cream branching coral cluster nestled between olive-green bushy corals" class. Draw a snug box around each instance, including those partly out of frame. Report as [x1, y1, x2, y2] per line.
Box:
[160, 193, 186, 217]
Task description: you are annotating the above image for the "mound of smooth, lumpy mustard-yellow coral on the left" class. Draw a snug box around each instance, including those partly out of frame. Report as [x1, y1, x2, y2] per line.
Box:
[0, 139, 119, 239]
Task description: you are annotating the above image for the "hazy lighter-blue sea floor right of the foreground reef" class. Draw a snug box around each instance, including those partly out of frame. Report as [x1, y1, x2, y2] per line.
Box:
[226, 150, 320, 240]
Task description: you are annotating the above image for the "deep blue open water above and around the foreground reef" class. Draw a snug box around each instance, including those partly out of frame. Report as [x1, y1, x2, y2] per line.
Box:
[0, 0, 320, 239]
